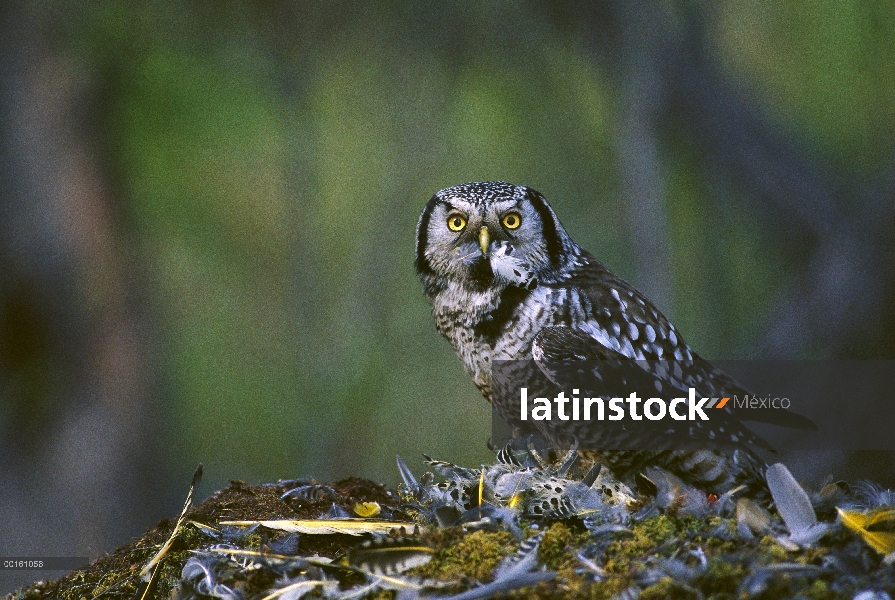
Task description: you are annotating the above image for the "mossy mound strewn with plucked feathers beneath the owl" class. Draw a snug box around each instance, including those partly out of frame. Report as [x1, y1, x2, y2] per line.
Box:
[7, 468, 895, 600]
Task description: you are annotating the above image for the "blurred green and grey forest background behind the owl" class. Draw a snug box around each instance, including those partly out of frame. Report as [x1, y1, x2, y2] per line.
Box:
[0, 0, 895, 592]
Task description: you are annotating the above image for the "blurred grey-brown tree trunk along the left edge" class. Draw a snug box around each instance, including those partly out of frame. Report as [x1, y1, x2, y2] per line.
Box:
[0, 3, 163, 591]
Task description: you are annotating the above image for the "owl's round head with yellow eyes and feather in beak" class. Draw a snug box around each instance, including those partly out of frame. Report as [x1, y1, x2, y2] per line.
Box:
[416, 181, 577, 289]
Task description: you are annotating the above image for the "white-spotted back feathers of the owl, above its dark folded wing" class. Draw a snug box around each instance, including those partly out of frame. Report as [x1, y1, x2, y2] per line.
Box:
[563, 253, 818, 431]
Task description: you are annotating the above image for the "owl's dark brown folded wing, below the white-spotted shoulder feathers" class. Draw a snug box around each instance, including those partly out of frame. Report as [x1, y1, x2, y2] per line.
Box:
[532, 325, 773, 450]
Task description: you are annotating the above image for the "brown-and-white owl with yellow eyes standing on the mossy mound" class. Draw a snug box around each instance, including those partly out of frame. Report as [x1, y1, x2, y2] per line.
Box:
[416, 181, 814, 493]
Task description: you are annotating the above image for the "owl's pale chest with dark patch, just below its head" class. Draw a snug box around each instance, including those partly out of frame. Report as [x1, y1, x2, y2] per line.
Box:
[433, 287, 568, 400]
